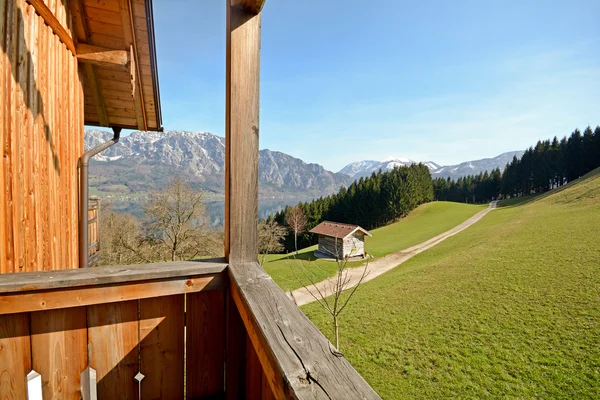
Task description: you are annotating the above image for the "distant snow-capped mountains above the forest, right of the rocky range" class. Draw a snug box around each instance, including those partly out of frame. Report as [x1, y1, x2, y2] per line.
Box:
[339, 151, 523, 179]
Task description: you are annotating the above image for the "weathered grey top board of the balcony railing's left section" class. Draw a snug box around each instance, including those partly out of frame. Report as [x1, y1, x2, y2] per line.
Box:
[0, 259, 227, 294]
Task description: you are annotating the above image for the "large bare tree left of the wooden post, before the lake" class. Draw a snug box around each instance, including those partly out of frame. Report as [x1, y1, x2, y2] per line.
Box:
[145, 178, 210, 261]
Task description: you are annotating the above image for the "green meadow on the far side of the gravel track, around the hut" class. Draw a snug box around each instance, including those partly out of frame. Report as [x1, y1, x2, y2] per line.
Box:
[264, 201, 487, 290]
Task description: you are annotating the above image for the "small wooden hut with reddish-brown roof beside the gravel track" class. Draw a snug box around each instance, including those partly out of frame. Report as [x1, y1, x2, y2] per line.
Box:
[310, 221, 372, 259]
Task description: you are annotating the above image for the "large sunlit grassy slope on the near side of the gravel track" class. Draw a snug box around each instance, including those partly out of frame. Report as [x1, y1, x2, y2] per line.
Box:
[303, 170, 600, 399]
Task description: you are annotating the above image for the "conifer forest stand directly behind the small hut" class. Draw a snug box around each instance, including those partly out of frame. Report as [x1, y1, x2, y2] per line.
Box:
[274, 164, 433, 251]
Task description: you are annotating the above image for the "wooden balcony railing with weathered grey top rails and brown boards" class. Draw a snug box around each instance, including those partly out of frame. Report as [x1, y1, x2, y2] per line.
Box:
[0, 260, 378, 399]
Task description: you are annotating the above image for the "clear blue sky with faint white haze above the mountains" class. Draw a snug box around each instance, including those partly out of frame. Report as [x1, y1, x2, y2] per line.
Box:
[154, 0, 600, 171]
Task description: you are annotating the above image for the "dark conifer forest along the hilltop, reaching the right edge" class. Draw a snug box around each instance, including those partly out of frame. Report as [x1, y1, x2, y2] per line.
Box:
[433, 127, 600, 203]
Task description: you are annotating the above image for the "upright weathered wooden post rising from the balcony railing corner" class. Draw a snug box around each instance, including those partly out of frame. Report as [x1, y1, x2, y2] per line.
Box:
[225, 6, 260, 262]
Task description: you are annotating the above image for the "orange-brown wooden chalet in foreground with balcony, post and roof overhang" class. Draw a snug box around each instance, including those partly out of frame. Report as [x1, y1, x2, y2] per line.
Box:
[0, 0, 378, 400]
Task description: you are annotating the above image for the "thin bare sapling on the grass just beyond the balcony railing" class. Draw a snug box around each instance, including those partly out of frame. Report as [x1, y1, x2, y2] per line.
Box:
[290, 244, 369, 350]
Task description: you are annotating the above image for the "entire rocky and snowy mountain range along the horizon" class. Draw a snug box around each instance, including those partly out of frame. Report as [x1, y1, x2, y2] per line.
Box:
[85, 130, 522, 199]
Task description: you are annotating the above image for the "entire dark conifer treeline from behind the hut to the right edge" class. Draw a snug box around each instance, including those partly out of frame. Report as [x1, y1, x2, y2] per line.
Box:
[271, 127, 600, 251]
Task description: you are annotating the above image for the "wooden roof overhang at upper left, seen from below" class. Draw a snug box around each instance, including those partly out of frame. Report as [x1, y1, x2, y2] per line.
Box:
[69, 0, 162, 131]
